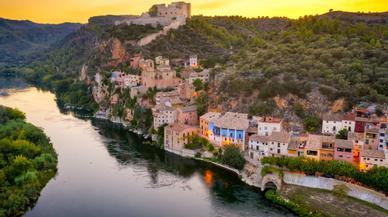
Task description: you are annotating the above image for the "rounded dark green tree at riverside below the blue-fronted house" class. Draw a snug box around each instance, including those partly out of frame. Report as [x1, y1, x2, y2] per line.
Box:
[221, 145, 245, 170]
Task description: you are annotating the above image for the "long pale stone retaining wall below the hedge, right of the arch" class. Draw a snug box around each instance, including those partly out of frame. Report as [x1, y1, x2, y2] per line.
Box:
[283, 172, 388, 210]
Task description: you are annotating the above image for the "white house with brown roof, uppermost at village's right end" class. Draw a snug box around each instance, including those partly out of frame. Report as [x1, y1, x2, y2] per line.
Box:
[322, 114, 356, 135]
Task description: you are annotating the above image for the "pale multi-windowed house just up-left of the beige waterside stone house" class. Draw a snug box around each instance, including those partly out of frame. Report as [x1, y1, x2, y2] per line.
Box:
[152, 105, 177, 129]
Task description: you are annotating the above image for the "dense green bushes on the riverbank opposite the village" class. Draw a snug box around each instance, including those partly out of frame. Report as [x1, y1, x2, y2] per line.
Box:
[0, 106, 57, 217]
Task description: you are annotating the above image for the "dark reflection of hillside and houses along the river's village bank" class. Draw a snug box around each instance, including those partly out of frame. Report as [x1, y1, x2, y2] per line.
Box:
[93, 120, 252, 198]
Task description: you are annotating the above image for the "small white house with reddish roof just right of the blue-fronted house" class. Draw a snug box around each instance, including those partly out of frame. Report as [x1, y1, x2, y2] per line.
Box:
[254, 117, 283, 136]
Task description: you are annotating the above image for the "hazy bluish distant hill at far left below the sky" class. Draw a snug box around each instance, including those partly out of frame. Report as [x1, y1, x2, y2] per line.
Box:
[0, 18, 81, 67]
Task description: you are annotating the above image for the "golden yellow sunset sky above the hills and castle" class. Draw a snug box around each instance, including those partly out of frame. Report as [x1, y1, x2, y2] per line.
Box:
[0, 0, 388, 23]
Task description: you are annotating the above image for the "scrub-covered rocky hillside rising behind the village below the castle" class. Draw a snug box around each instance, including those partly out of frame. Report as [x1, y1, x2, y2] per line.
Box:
[19, 12, 388, 117]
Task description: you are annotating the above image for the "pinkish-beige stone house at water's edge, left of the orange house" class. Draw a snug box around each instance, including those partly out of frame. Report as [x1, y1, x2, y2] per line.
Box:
[164, 123, 197, 151]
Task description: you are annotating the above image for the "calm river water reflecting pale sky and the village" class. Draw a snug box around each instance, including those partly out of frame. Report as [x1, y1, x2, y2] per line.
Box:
[0, 82, 293, 217]
